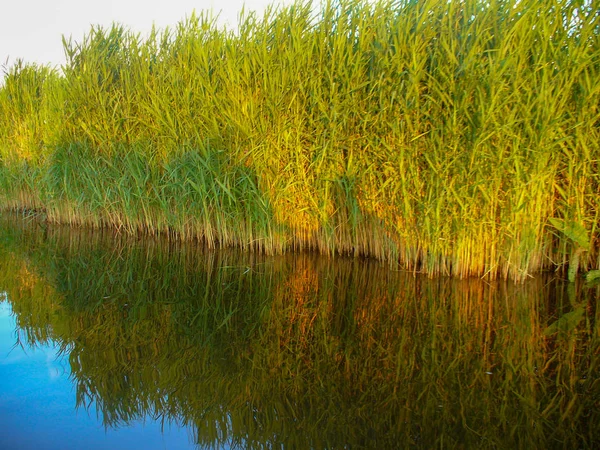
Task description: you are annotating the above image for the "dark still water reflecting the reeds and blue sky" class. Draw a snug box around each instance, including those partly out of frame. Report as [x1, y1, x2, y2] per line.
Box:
[0, 217, 600, 449]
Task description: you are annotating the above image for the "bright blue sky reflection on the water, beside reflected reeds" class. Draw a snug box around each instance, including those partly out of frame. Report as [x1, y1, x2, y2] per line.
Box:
[0, 293, 194, 450]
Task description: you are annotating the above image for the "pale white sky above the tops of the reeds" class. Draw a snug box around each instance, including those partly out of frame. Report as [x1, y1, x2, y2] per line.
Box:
[0, 0, 292, 70]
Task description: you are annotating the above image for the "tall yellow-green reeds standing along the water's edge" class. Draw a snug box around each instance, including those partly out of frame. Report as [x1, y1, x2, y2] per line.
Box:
[0, 0, 600, 279]
